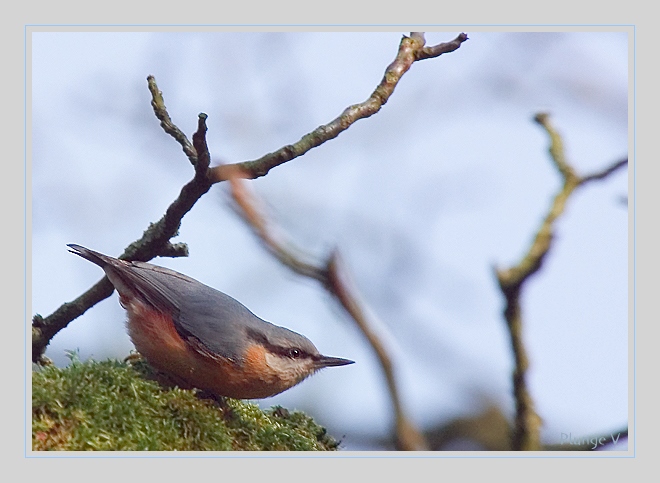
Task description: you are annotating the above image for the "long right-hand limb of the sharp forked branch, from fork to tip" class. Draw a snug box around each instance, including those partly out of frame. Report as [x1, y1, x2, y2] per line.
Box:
[209, 33, 468, 183]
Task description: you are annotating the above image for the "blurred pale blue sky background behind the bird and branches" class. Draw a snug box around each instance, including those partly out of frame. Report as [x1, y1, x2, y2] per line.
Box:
[28, 29, 630, 450]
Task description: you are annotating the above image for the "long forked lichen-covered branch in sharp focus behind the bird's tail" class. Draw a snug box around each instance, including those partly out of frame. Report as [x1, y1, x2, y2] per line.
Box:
[32, 34, 467, 362]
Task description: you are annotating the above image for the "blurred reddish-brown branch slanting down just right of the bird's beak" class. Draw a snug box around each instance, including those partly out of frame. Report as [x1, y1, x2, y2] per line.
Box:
[229, 177, 428, 451]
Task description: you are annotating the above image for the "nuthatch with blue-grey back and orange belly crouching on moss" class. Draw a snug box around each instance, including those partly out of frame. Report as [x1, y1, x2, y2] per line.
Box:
[68, 245, 353, 399]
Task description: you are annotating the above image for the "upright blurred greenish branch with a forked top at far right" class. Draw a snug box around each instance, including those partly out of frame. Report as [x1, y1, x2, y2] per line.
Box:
[496, 113, 628, 450]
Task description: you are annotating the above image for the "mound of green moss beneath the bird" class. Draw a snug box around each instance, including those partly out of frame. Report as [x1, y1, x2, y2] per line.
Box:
[32, 357, 338, 451]
